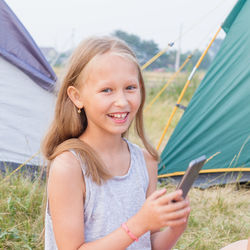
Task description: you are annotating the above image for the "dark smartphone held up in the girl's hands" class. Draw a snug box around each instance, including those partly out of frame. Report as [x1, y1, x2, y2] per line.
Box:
[176, 155, 207, 199]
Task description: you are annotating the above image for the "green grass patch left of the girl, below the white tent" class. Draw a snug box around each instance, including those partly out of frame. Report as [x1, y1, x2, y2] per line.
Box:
[0, 173, 45, 249]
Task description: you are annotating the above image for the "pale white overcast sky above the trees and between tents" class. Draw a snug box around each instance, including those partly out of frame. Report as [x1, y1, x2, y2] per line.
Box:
[5, 0, 237, 52]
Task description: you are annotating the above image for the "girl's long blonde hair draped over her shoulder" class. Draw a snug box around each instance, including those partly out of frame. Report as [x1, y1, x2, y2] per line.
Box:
[42, 37, 158, 185]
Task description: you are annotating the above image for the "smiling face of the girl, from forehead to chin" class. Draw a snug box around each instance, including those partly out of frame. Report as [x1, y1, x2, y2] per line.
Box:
[77, 53, 141, 135]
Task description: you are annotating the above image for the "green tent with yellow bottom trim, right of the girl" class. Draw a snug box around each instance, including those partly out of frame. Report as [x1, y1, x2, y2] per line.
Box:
[158, 0, 250, 186]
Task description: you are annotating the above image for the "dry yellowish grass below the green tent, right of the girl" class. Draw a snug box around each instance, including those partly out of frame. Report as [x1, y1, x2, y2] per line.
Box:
[176, 185, 250, 250]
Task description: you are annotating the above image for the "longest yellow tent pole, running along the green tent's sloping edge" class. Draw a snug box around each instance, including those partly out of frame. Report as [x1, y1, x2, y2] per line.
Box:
[157, 27, 221, 150]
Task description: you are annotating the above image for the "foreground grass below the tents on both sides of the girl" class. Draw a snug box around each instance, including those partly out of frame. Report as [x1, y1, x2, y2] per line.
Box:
[0, 174, 250, 250]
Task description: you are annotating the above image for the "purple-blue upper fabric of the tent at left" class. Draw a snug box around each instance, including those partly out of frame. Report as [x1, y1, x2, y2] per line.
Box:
[0, 0, 56, 92]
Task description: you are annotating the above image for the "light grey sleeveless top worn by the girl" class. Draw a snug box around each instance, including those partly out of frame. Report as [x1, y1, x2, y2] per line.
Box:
[45, 139, 151, 250]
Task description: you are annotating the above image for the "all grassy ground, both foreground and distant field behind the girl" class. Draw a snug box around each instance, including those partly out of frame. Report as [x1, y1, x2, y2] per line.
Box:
[0, 72, 250, 250]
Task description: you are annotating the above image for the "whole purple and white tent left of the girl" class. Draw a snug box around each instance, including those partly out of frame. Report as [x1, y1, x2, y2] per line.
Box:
[0, 0, 56, 171]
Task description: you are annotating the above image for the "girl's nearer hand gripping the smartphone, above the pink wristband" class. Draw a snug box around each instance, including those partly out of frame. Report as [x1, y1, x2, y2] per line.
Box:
[138, 188, 190, 231]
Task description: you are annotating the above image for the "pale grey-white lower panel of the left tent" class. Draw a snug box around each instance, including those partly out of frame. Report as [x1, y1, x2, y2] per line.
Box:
[0, 57, 56, 165]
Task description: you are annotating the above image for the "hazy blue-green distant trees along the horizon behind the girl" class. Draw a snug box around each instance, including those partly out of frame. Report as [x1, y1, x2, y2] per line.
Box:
[48, 30, 223, 72]
